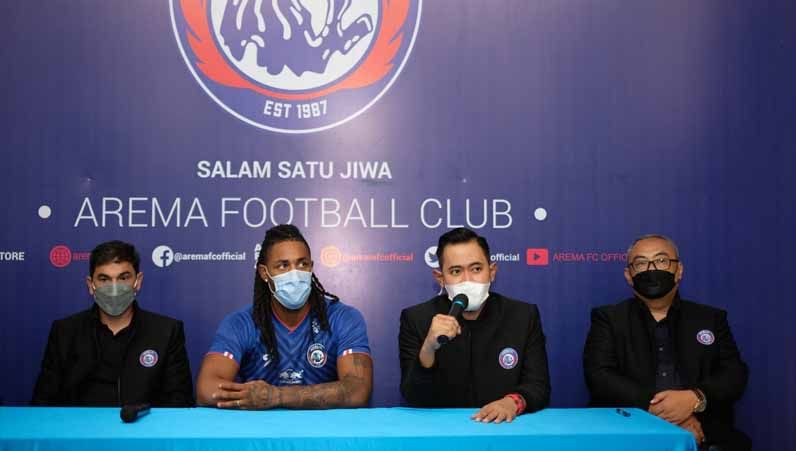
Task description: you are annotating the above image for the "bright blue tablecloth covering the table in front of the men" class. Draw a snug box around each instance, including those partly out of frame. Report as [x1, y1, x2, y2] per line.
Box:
[0, 407, 696, 451]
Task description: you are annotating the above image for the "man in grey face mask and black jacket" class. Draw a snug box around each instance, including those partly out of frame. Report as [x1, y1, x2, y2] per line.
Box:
[31, 241, 194, 407]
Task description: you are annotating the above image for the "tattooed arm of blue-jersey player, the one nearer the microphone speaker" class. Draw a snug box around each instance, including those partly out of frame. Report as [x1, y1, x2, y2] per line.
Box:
[211, 353, 373, 410]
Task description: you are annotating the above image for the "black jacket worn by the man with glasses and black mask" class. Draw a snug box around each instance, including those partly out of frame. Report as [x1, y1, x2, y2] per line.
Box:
[583, 296, 748, 445]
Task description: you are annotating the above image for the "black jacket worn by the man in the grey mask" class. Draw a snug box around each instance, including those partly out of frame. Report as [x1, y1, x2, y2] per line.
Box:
[31, 305, 194, 407]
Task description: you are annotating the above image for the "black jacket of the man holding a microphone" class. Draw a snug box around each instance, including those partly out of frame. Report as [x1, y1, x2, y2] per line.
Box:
[398, 293, 550, 412]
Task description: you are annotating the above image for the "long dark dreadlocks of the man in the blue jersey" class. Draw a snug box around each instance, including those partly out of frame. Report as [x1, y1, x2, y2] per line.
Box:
[252, 224, 340, 364]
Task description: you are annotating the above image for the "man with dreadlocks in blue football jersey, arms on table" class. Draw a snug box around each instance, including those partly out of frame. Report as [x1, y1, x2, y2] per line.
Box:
[196, 225, 373, 409]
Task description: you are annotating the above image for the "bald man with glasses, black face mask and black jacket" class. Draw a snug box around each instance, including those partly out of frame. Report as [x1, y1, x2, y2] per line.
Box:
[583, 235, 751, 451]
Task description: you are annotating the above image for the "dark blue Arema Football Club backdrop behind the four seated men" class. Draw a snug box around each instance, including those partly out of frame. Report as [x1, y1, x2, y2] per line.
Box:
[0, 0, 796, 449]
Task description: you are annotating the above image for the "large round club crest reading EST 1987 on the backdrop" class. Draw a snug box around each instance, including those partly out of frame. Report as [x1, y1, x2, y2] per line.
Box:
[170, 0, 422, 133]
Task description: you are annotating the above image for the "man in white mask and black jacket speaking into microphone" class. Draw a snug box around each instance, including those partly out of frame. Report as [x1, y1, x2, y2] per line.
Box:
[398, 228, 550, 423]
